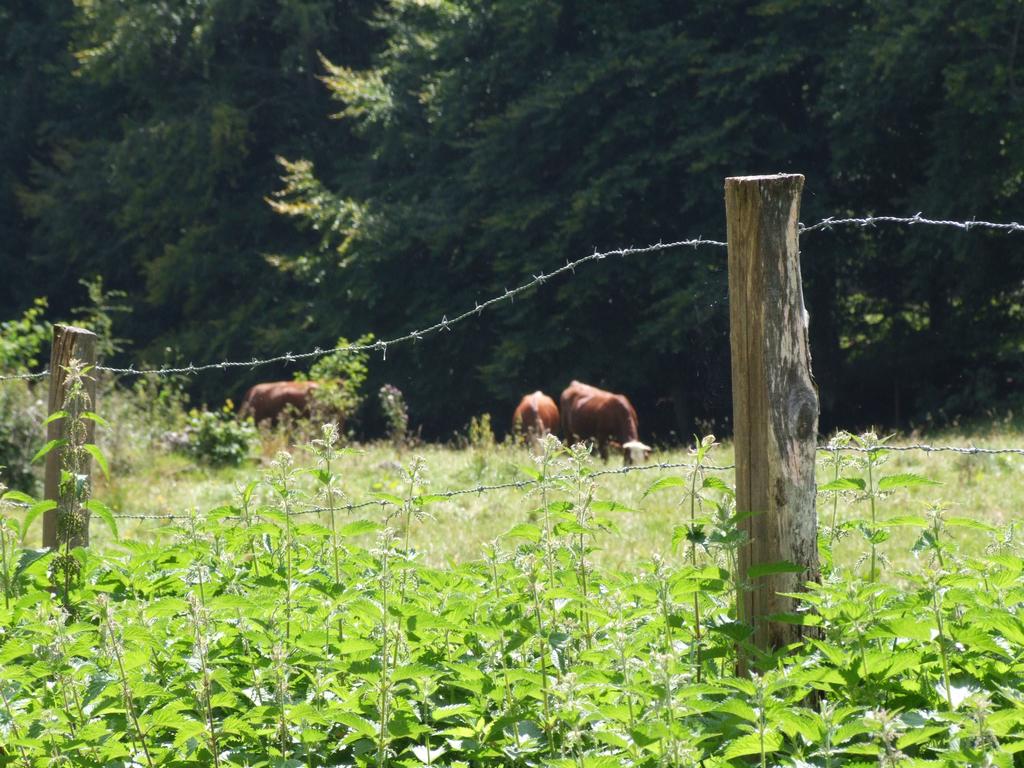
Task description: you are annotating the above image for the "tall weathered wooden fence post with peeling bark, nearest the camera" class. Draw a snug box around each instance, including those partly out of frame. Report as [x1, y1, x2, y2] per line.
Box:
[725, 174, 820, 671]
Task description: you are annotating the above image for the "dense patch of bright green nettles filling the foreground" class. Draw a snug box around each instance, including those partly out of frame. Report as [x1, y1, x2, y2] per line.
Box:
[0, 430, 1024, 768]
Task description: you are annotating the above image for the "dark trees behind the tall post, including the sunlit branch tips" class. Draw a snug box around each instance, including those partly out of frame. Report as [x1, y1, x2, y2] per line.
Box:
[268, 0, 1024, 432]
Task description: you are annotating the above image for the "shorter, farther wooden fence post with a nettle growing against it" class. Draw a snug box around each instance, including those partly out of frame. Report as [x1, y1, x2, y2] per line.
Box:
[43, 326, 96, 549]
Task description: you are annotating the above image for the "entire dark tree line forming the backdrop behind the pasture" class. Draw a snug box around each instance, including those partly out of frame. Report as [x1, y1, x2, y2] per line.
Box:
[0, 0, 1024, 437]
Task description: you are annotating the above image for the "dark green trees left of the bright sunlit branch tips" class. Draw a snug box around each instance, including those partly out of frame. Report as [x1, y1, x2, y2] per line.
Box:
[6, 0, 379, 400]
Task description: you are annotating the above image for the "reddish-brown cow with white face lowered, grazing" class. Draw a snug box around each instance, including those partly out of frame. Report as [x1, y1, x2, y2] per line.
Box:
[560, 381, 651, 464]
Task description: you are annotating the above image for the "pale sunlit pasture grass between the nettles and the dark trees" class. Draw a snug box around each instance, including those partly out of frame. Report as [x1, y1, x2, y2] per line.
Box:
[72, 417, 1024, 568]
